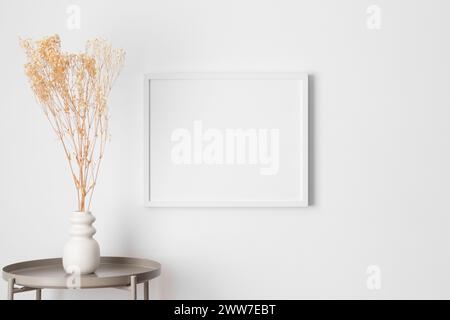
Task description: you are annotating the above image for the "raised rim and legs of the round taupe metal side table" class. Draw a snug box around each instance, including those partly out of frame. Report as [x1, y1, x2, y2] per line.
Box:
[3, 257, 161, 300]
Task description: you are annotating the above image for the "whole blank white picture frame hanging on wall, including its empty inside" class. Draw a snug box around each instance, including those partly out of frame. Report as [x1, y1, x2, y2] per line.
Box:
[144, 73, 308, 207]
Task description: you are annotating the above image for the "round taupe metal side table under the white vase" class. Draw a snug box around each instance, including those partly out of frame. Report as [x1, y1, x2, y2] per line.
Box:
[3, 257, 161, 300]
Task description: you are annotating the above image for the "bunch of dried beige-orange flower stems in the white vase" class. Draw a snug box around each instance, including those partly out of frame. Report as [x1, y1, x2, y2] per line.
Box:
[20, 35, 125, 212]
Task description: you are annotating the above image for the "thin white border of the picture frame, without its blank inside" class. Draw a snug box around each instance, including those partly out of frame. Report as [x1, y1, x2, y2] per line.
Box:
[143, 72, 309, 207]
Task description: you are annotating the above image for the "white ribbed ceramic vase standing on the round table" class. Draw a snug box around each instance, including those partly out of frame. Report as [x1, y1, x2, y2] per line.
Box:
[63, 211, 100, 274]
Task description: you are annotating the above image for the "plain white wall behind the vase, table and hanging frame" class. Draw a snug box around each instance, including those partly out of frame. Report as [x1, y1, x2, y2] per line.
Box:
[0, 0, 450, 299]
